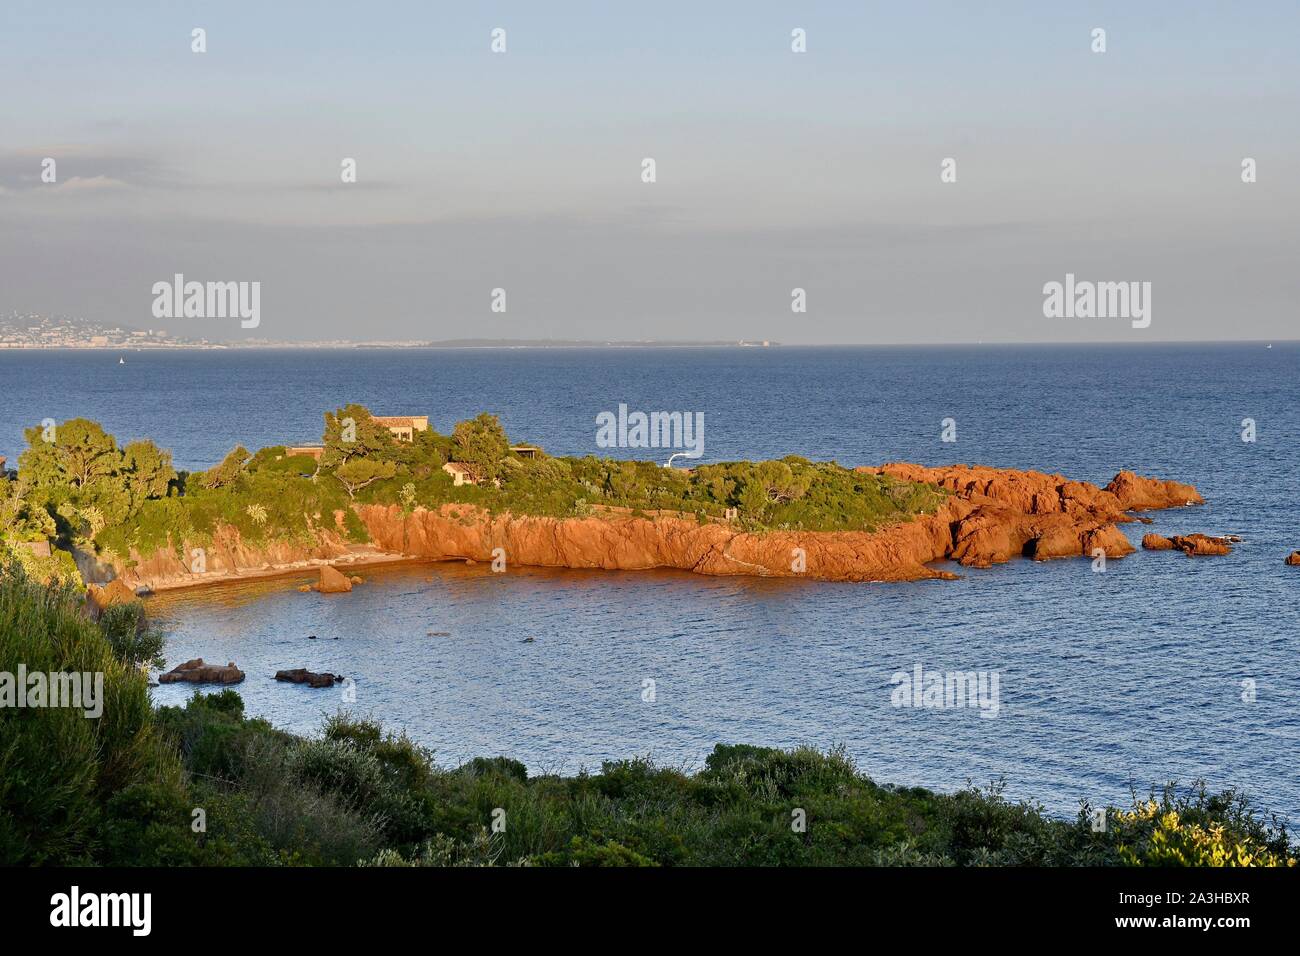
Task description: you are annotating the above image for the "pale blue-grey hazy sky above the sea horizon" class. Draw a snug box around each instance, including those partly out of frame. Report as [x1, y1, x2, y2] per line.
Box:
[0, 0, 1300, 345]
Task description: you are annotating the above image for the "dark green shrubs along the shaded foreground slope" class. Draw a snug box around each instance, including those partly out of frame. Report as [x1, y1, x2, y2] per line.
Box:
[0, 564, 1295, 866]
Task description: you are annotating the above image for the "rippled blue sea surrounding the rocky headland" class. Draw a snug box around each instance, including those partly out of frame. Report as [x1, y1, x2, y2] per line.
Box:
[0, 343, 1300, 822]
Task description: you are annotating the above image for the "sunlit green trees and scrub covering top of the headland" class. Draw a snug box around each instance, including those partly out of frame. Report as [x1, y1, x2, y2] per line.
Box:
[0, 405, 943, 583]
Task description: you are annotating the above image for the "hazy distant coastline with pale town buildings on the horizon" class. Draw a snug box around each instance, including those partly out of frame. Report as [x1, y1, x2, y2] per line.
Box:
[0, 311, 777, 350]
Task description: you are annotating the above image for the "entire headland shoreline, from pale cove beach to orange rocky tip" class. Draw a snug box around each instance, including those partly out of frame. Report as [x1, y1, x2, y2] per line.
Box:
[83, 463, 1203, 591]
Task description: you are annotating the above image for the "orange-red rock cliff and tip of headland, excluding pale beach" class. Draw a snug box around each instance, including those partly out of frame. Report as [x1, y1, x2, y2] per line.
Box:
[358, 463, 1200, 581]
